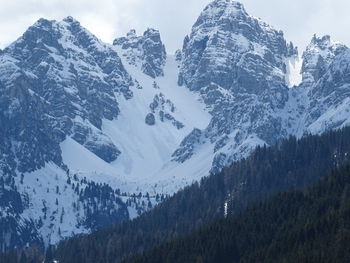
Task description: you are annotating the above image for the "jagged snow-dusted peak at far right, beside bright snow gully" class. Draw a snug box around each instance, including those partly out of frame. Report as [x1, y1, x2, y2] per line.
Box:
[301, 36, 350, 133]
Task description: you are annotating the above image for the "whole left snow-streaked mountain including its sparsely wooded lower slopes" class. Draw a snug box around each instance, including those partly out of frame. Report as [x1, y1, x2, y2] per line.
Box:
[0, 14, 173, 250]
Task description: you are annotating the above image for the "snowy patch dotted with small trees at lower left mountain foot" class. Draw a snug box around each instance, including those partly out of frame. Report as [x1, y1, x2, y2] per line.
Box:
[16, 163, 87, 245]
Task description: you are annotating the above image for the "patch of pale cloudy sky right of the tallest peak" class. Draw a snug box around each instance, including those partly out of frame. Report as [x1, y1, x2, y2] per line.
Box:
[241, 0, 350, 53]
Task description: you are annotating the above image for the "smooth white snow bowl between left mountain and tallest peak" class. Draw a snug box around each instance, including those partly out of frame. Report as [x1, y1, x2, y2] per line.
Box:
[61, 54, 213, 194]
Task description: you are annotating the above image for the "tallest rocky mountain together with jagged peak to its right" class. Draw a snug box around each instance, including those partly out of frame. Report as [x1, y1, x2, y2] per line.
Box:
[173, 0, 350, 179]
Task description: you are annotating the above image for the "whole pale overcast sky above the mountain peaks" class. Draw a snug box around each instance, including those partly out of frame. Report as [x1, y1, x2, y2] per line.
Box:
[0, 0, 350, 53]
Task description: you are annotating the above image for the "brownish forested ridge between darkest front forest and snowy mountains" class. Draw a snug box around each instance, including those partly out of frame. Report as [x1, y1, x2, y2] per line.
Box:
[2, 128, 350, 263]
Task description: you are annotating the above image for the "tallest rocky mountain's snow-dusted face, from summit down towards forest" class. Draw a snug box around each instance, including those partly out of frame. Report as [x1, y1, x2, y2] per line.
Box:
[174, 0, 297, 171]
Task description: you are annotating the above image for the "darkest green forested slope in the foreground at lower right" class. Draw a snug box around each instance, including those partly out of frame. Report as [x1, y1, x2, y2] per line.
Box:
[124, 165, 350, 263]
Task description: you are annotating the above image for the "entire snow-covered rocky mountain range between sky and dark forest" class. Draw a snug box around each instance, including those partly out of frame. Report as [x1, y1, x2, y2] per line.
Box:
[0, 0, 350, 254]
